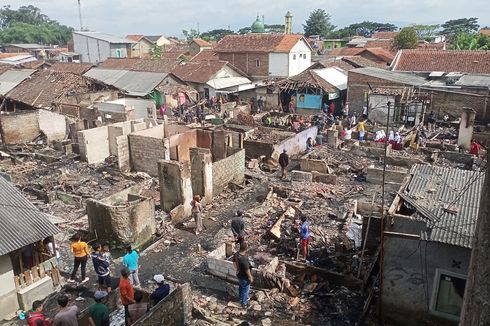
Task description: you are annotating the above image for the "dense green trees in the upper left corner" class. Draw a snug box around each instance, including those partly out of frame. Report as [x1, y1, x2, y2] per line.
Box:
[0, 5, 73, 45]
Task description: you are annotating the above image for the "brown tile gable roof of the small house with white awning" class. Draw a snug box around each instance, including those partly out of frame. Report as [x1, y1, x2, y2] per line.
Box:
[172, 60, 246, 84]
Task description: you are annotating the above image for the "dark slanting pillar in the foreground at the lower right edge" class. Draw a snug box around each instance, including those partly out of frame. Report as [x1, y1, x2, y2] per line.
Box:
[460, 149, 490, 326]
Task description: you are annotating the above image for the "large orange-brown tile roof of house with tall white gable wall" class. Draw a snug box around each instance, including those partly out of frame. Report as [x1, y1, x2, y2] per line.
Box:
[214, 33, 309, 53]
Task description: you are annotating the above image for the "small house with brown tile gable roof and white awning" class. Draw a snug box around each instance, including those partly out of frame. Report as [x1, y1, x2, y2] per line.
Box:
[172, 60, 254, 99]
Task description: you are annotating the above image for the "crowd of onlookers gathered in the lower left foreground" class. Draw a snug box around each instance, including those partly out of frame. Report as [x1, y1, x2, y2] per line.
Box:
[26, 234, 174, 326]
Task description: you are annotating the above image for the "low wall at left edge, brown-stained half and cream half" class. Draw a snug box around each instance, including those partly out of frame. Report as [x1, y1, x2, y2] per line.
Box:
[0, 109, 67, 144]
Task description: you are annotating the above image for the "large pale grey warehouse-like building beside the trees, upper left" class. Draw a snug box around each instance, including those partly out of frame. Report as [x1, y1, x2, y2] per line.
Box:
[73, 32, 136, 63]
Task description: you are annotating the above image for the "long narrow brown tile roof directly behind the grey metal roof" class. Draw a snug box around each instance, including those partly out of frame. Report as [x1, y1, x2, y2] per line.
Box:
[99, 58, 179, 73]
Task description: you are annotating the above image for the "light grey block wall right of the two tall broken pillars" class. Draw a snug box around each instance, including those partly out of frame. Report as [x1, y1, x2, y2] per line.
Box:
[213, 147, 245, 196]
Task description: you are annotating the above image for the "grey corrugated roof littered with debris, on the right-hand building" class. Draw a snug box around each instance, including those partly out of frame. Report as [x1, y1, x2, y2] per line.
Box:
[405, 164, 485, 248]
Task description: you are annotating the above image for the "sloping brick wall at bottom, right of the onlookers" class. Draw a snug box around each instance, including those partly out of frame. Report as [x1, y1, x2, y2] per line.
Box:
[133, 283, 192, 326]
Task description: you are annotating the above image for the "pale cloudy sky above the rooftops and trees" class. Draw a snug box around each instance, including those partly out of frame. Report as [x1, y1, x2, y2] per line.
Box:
[3, 0, 490, 36]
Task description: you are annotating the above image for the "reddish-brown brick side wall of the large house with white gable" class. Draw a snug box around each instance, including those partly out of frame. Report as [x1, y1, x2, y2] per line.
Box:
[218, 53, 269, 77]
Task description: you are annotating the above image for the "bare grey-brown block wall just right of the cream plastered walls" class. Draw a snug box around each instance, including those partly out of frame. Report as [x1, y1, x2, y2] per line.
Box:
[129, 134, 170, 177]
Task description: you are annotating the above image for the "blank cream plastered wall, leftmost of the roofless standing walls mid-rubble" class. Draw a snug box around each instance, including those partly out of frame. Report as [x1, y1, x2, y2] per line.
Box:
[78, 126, 110, 164]
